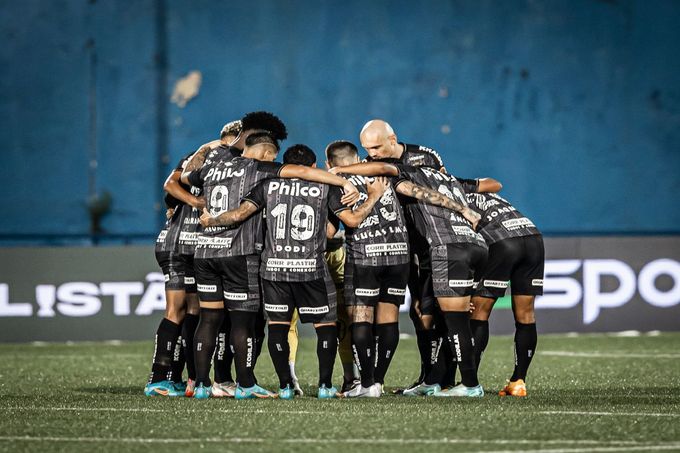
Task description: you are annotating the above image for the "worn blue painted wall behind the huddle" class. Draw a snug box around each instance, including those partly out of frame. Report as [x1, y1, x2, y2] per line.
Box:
[0, 0, 680, 238]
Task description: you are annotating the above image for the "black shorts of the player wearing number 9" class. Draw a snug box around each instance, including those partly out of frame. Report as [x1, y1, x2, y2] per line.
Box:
[195, 255, 260, 312]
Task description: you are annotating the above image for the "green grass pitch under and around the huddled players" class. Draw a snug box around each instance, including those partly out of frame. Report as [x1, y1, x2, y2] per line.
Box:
[0, 334, 680, 453]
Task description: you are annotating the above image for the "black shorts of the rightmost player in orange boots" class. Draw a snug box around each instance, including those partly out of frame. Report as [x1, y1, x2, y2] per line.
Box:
[474, 235, 545, 299]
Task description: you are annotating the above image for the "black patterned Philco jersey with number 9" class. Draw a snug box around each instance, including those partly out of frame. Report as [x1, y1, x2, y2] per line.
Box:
[189, 153, 285, 259]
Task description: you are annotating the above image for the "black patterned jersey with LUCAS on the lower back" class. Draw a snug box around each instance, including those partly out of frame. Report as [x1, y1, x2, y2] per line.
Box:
[341, 174, 409, 266]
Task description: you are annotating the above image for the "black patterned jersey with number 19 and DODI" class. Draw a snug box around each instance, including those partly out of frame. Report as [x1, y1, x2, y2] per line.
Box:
[243, 178, 348, 282]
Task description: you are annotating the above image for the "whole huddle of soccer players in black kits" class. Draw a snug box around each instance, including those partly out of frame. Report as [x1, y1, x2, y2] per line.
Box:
[144, 111, 544, 399]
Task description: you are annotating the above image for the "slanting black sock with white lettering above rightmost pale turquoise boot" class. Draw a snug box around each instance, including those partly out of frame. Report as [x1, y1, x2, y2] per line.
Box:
[444, 311, 479, 387]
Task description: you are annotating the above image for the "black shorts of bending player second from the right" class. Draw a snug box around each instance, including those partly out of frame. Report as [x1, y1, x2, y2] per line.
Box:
[430, 243, 487, 297]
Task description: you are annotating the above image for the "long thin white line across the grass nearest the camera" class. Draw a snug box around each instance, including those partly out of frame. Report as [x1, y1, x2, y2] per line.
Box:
[0, 436, 664, 444]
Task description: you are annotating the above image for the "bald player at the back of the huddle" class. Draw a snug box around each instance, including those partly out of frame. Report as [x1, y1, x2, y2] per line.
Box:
[359, 119, 448, 393]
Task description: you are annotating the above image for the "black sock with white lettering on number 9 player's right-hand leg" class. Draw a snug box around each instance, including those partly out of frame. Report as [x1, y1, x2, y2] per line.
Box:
[229, 310, 257, 388]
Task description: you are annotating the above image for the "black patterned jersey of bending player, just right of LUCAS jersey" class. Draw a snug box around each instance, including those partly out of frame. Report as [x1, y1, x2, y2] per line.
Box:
[394, 165, 486, 247]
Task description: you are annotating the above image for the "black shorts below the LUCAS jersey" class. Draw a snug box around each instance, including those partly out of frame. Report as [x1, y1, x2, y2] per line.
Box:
[345, 261, 410, 307]
